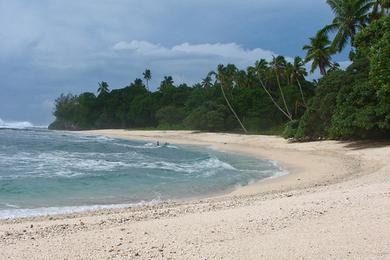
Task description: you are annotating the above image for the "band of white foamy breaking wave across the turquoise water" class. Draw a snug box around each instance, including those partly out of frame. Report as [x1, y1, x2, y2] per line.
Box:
[0, 151, 238, 180]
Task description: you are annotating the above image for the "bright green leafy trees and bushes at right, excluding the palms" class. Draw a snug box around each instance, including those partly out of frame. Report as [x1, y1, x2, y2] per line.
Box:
[295, 16, 390, 139]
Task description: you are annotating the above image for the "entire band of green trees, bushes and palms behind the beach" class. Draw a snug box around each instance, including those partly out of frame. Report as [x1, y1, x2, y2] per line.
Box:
[50, 0, 390, 140]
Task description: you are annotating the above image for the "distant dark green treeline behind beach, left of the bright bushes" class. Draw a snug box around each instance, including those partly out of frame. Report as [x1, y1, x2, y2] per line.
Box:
[50, 56, 314, 132]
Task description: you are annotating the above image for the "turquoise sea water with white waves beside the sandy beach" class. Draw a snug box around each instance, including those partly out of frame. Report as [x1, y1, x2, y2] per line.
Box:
[0, 128, 281, 218]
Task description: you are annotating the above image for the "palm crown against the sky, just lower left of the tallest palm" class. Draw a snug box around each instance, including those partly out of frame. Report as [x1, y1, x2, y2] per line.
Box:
[303, 31, 334, 75]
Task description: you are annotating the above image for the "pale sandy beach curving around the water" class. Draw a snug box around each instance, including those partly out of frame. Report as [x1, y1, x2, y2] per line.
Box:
[0, 130, 390, 259]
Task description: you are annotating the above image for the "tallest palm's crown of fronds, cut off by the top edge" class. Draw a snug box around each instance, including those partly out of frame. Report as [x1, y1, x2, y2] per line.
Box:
[322, 0, 374, 52]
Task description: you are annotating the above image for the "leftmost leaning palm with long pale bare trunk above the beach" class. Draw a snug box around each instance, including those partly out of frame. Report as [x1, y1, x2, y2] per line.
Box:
[208, 64, 248, 133]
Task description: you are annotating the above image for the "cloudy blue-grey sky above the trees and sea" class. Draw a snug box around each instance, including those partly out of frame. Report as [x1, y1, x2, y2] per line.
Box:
[0, 0, 347, 125]
